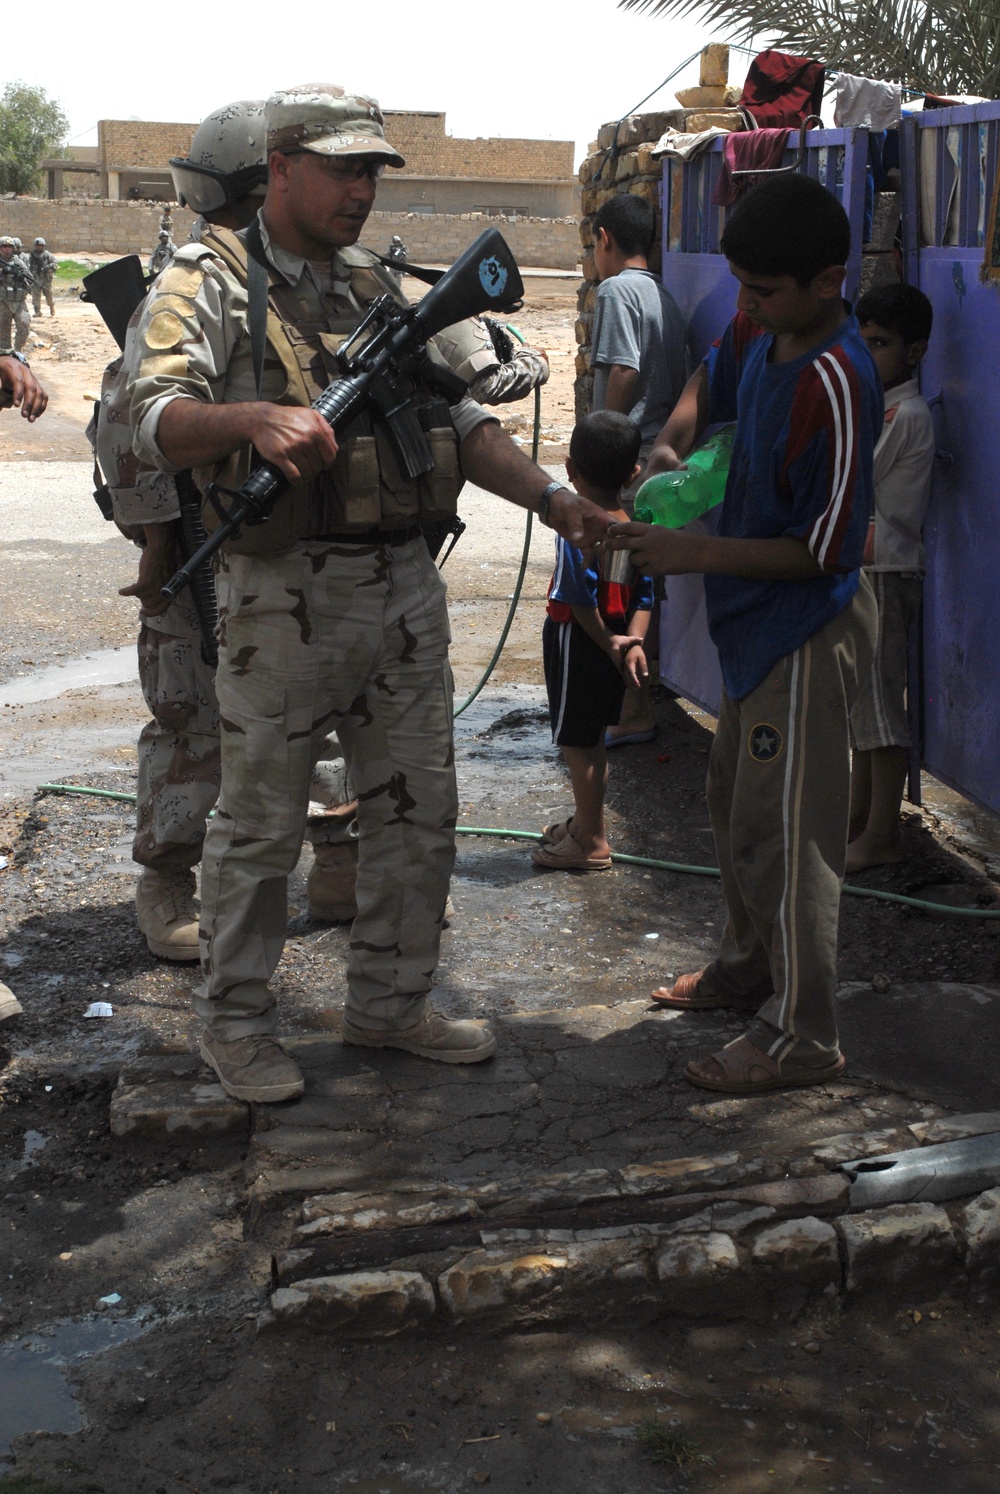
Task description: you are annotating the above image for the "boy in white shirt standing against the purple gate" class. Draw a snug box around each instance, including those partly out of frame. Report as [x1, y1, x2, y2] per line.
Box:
[848, 284, 934, 872]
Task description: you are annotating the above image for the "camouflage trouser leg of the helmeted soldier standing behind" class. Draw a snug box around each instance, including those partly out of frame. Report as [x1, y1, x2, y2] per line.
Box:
[132, 598, 221, 871]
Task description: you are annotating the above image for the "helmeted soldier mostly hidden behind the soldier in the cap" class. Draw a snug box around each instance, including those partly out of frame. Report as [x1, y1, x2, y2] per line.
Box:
[96, 108, 266, 961]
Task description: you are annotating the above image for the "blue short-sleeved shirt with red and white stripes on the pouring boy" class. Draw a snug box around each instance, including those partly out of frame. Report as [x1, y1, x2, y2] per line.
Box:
[706, 312, 882, 701]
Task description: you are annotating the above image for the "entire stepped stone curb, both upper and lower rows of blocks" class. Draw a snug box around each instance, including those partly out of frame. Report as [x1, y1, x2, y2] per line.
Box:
[260, 1113, 1000, 1336]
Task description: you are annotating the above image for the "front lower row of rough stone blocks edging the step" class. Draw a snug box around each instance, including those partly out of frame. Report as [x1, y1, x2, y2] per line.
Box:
[260, 1189, 1000, 1337]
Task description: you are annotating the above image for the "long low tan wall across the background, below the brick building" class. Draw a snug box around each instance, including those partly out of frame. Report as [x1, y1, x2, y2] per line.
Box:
[0, 197, 580, 270]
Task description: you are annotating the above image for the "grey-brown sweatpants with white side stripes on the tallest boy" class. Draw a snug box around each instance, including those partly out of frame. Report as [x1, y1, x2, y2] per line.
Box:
[693, 577, 877, 1067]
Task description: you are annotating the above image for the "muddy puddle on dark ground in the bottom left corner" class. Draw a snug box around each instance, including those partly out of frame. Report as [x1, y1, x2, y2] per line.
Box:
[0, 1316, 148, 1469]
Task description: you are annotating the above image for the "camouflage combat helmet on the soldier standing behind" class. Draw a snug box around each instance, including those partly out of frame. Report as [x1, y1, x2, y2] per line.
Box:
[170, 99, 268, 214]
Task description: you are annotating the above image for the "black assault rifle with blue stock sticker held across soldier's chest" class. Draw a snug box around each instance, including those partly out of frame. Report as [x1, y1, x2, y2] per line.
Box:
[163, 229, 525, 601]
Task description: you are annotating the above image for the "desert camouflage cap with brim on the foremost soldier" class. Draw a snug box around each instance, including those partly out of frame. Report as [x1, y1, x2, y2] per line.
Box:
[265, 84, 407, 166]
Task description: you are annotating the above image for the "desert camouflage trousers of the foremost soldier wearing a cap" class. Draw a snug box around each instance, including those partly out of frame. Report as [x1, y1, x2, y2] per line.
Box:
[194, 539, 457, 1038]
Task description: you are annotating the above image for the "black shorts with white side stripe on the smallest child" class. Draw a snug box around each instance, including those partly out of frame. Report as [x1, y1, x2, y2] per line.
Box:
[541, 617, 625, 747]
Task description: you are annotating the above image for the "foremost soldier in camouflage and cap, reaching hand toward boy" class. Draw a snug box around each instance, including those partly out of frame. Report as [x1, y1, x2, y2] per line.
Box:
[130, 85, 607, 1101]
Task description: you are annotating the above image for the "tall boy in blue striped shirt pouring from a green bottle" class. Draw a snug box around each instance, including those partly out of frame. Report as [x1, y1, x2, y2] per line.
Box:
[608, 175, 882, 1094]
